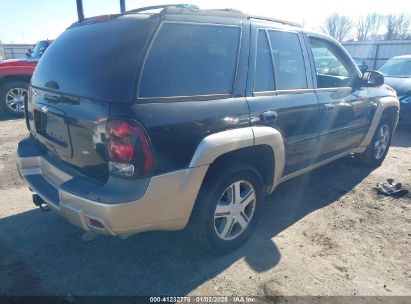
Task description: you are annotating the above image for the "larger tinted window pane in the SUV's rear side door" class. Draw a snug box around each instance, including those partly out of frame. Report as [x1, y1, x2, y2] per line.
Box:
[269, 31, 307, 90]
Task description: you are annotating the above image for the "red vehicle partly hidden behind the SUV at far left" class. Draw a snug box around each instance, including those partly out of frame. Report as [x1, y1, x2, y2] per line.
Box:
[0, 40, 51, 116]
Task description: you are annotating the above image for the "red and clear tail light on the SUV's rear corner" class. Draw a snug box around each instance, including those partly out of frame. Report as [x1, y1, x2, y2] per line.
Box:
[107, 119, 154, 177]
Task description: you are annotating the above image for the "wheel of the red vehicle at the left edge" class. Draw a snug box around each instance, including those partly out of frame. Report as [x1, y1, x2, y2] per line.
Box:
[0, 80, 29, 117]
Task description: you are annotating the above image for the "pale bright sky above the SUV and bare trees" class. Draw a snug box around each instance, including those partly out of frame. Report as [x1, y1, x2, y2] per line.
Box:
[0, 0, 411, 43]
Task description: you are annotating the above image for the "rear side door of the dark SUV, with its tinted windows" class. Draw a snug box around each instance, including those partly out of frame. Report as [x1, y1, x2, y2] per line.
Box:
[247, 23, 319, 174]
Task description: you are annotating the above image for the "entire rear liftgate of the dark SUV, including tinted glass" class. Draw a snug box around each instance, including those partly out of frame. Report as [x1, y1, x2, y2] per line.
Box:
[26, 15, 158, 182]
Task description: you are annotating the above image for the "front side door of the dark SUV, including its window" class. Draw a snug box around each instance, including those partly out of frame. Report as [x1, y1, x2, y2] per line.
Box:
[307, 35, 373, 160]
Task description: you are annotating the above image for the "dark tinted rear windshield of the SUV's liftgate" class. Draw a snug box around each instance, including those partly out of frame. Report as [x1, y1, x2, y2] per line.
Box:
[32, 15, 157, 102]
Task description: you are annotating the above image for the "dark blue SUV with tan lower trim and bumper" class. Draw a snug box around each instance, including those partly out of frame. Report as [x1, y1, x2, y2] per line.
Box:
[18, 6, 399, 252]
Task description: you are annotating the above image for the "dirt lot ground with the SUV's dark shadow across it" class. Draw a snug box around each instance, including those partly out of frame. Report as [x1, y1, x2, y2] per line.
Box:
[0, 114, 411, 296]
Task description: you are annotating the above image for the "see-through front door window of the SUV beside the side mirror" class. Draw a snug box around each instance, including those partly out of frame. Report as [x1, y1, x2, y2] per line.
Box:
[310, 38, 353, 88]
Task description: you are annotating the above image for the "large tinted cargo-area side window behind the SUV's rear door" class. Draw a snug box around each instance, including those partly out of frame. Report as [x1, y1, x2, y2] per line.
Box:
[139, 23, 240, 98]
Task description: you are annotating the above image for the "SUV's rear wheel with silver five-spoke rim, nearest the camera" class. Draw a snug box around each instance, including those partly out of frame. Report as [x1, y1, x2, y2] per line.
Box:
[188, 164, 265, 254]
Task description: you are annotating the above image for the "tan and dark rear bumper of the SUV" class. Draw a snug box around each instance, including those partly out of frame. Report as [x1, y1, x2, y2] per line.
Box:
[17, 138, 208, 236]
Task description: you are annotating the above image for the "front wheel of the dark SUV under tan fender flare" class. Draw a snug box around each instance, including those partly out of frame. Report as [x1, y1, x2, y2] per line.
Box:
[358, 120, 392, 168]
